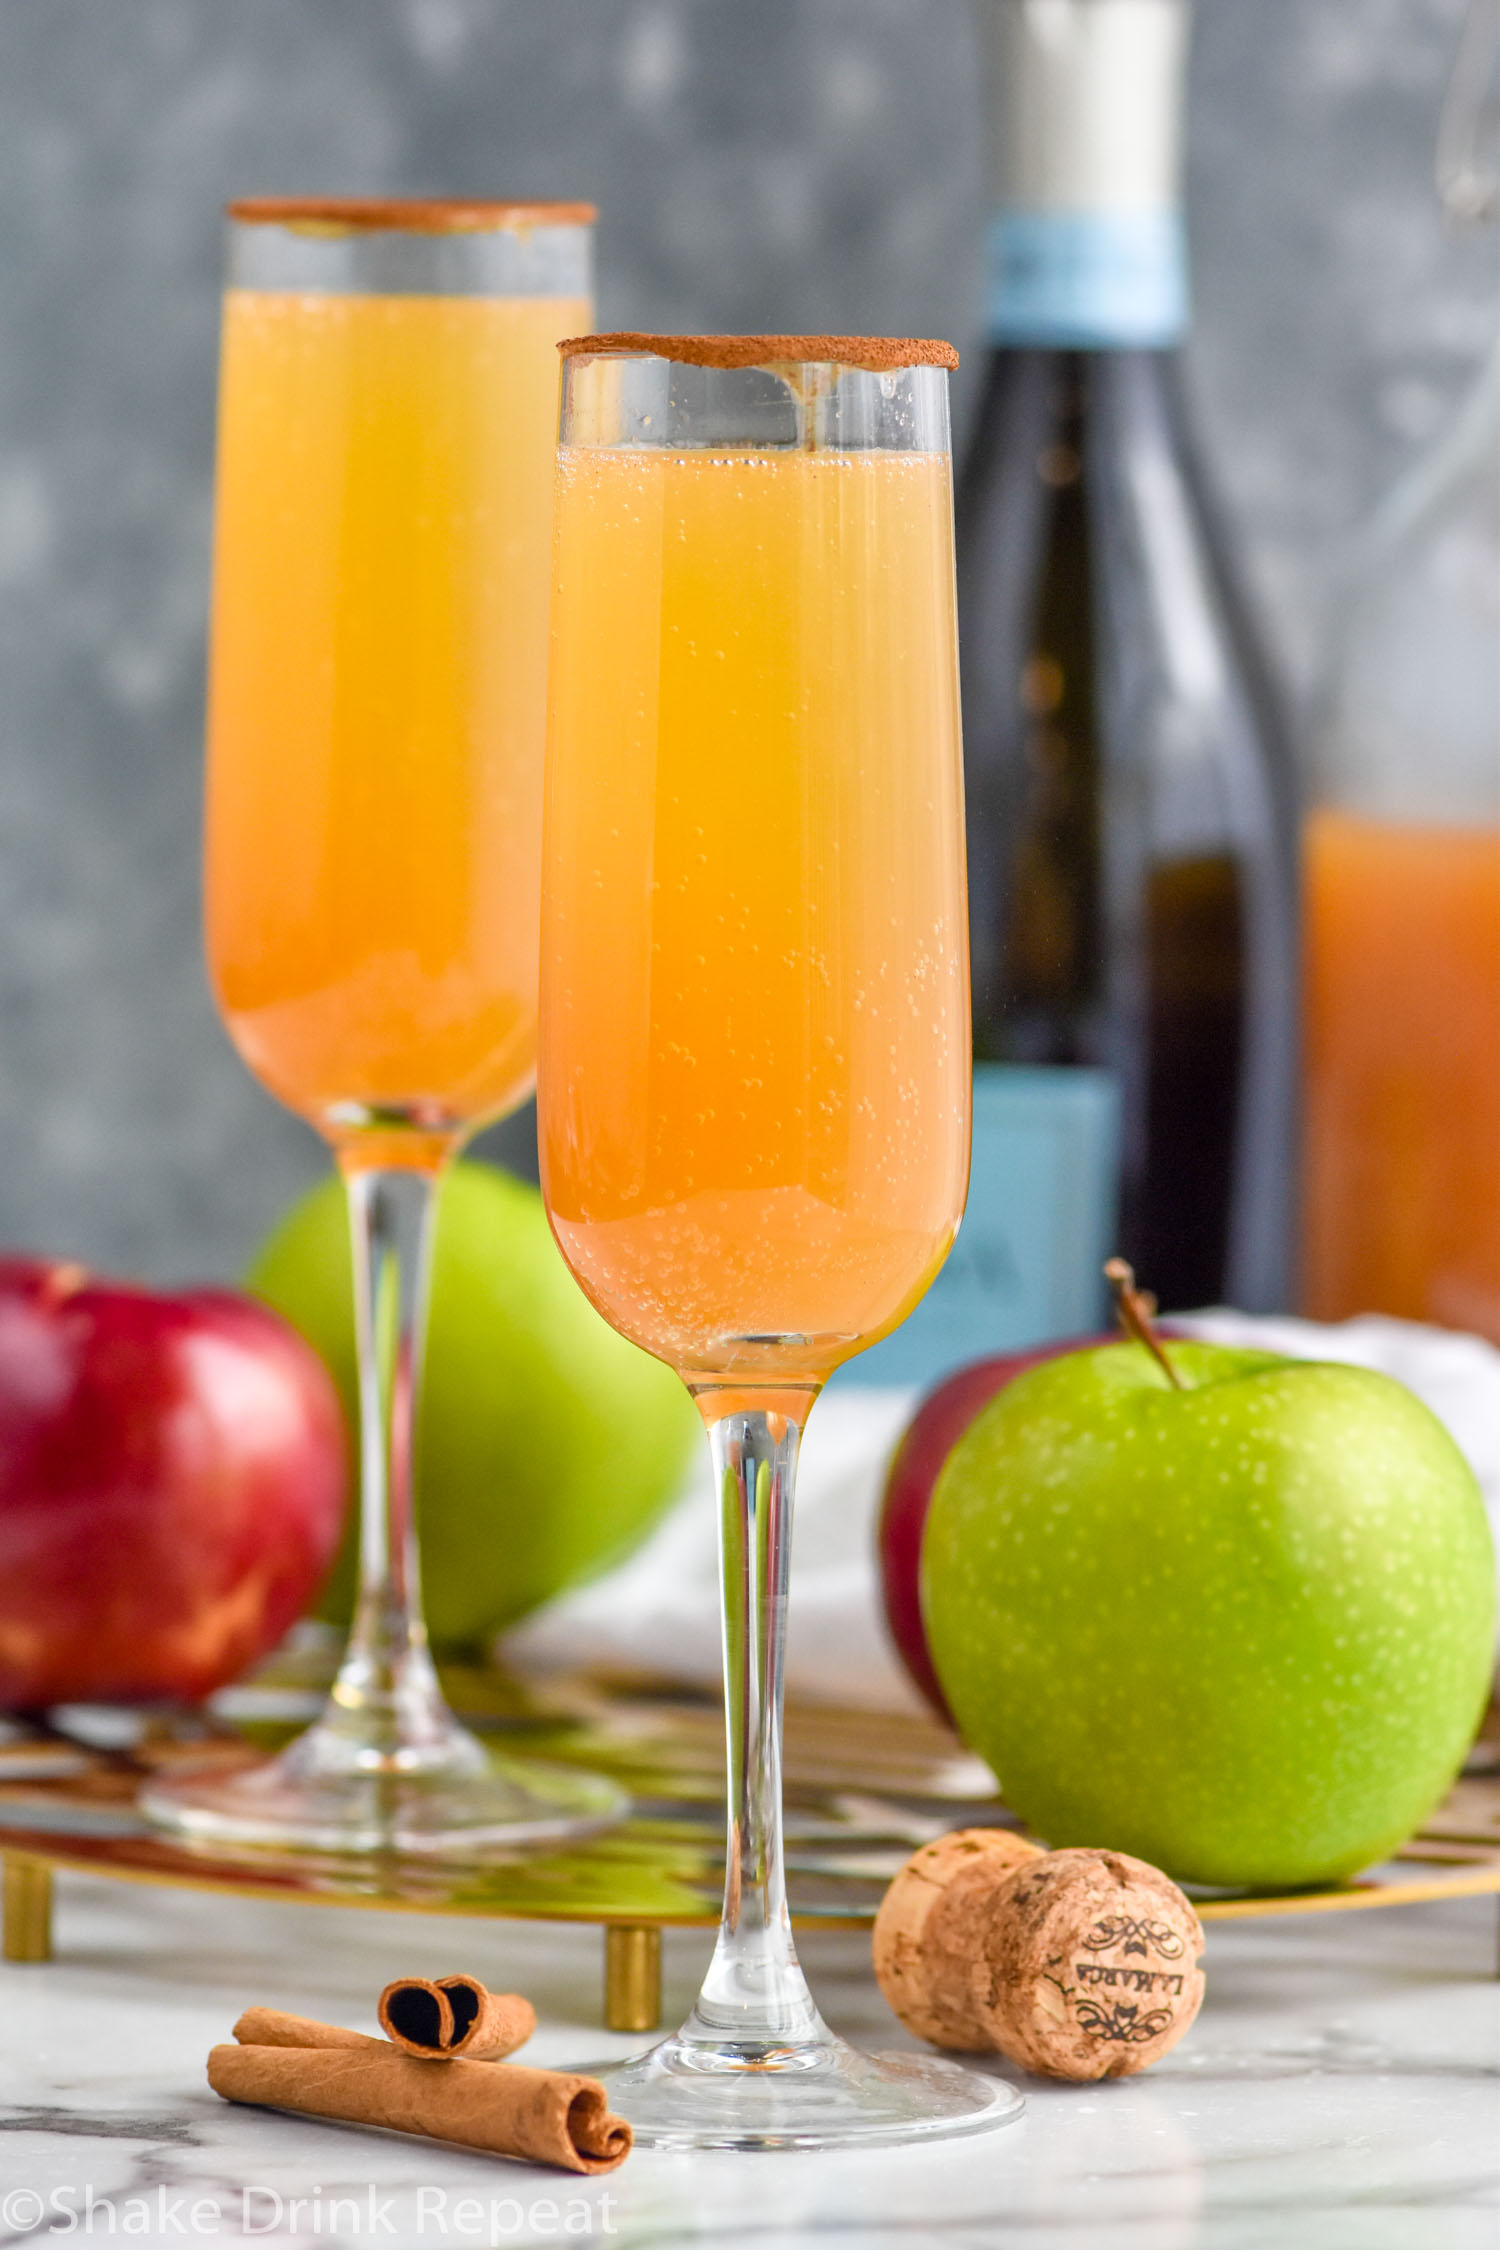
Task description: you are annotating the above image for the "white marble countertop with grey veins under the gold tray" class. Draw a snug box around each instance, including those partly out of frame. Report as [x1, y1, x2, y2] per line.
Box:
[0, 1877, 1500, 2250]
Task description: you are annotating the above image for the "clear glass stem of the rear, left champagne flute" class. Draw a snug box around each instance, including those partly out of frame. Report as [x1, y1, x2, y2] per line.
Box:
[317, 1170, 481, 1773]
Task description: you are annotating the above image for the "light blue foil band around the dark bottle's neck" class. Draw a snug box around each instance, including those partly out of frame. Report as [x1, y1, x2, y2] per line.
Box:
[990, 209, 1187, 351]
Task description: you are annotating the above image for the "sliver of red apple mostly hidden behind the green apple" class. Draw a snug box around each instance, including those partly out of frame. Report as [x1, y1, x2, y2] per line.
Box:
[879, 1334, 1120, 1724]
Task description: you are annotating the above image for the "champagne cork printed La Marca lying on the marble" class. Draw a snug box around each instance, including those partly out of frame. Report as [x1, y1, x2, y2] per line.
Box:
[875, 1829, 1203, 2079]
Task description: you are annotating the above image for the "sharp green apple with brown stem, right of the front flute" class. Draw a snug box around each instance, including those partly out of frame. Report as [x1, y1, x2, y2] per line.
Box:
[922, 1343, 1496, 1890]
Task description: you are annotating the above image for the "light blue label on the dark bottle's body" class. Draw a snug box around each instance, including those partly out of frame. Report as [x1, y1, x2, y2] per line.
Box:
[839, 1062, 1120, 1384]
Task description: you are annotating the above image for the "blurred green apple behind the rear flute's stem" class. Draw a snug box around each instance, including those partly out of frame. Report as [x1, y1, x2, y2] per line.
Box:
[247, 1163, 702, 1649]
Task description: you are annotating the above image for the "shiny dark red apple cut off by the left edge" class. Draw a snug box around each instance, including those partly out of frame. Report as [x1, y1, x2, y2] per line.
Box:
[0, 1258, 349, 1710]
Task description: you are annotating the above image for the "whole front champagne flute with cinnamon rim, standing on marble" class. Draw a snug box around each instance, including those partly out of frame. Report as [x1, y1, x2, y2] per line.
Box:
[540, 335, 1021, 2149]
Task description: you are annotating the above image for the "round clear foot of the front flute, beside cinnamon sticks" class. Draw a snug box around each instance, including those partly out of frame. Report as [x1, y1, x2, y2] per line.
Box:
[591, 2030, 1025, 2149]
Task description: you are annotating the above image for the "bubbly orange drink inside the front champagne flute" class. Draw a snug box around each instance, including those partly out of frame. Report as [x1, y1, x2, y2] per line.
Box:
[542, 446, 969, 1379]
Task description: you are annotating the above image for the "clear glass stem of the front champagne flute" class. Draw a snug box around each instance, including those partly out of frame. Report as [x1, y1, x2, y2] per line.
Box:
[679, 1411, 828, 2054]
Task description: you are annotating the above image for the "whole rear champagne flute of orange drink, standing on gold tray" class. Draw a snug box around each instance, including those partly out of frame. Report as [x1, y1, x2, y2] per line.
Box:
[142, 200, 623, 1852]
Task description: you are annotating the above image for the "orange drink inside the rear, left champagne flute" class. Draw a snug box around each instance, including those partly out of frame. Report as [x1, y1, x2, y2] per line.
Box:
[207, 288, 585, 1150]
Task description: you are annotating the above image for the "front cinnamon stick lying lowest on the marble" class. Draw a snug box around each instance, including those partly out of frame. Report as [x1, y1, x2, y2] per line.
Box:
[209, 2052, 632, 2174]
